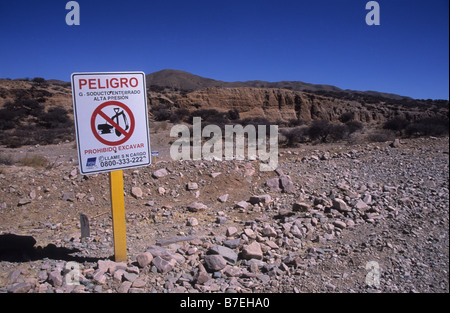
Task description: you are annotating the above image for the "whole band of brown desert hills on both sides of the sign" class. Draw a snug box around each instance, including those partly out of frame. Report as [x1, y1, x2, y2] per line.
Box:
[0, 70, 449, 146]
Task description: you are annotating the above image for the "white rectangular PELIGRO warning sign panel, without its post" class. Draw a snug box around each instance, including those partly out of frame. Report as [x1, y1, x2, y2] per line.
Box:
[72, 72, 151, 174]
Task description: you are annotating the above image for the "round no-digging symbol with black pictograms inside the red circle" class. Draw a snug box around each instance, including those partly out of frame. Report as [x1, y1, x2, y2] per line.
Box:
[91, 101, 135, 146]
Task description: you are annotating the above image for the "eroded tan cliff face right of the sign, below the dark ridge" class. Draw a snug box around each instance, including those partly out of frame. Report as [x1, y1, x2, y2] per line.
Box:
[157, 87, 442, 123]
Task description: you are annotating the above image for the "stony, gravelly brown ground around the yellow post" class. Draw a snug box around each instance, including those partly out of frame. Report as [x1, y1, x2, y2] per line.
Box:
[0, 137, 449, 293]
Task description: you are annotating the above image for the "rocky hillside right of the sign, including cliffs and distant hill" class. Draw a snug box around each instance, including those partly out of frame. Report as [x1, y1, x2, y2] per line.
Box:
[147, 70, 449, 123]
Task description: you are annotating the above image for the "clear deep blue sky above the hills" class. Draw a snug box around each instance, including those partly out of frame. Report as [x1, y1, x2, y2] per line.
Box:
[0, 0, 449, 99]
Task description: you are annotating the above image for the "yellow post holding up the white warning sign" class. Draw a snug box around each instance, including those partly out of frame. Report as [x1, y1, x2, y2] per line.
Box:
[109, 170, 127, 262]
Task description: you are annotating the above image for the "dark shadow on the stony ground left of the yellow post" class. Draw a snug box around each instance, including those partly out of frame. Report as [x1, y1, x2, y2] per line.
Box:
[0, 234, 112, 263]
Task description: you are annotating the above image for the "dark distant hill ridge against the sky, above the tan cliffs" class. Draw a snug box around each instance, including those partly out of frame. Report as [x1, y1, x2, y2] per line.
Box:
[146, 69, 408, 100]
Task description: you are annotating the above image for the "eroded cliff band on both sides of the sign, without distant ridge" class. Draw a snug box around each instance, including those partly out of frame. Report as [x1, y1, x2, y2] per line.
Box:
[0, 79, 442, 128]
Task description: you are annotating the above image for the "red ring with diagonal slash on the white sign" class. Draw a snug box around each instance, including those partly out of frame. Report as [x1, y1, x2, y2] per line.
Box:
[91, 101, 135, 146]
